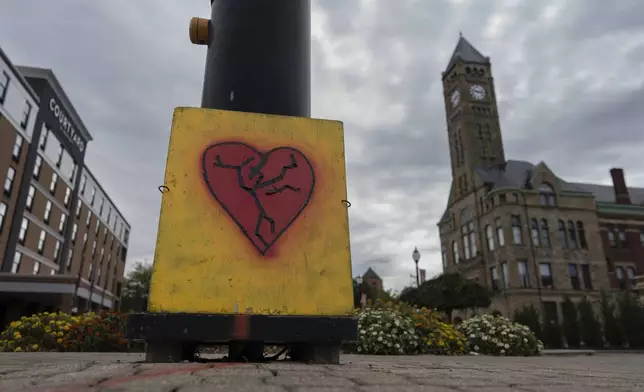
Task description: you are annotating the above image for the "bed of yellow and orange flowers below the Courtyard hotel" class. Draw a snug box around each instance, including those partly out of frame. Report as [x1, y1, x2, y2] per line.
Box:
[0, 312, 127, 352]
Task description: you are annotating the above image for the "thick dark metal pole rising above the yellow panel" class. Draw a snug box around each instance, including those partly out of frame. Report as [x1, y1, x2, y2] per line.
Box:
[201, 0, 311, 117]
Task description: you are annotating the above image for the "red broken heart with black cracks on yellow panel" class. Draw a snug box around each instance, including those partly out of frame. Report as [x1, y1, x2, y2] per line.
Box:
[202, 142, 315, 255]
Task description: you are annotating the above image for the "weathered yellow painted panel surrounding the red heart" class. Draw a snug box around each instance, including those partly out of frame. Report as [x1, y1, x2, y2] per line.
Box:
[148, 108, 353, 315]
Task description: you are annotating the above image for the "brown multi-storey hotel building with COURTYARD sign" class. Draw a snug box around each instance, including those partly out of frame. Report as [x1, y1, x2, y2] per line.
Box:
[0, 49, 130, 324]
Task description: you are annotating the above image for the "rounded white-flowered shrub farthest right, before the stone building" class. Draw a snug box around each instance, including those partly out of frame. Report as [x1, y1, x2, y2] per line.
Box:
[458, 314, 543, 356]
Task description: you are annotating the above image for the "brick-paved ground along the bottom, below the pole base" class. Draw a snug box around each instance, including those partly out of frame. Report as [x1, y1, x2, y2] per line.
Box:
[0, 353, 644, 392]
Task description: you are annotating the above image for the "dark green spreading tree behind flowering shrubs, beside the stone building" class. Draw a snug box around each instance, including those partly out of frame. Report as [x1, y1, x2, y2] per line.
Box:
[400, 273, 492, 323]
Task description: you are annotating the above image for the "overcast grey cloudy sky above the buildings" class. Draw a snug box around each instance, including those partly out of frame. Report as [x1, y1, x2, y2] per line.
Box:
[0, 0, 644, 289]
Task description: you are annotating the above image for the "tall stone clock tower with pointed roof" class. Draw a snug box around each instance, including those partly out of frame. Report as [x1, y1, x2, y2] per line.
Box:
[442, 35, 505, 202]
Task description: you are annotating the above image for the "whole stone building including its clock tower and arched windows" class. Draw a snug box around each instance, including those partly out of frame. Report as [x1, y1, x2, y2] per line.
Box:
[438, 36, 644, 321]
